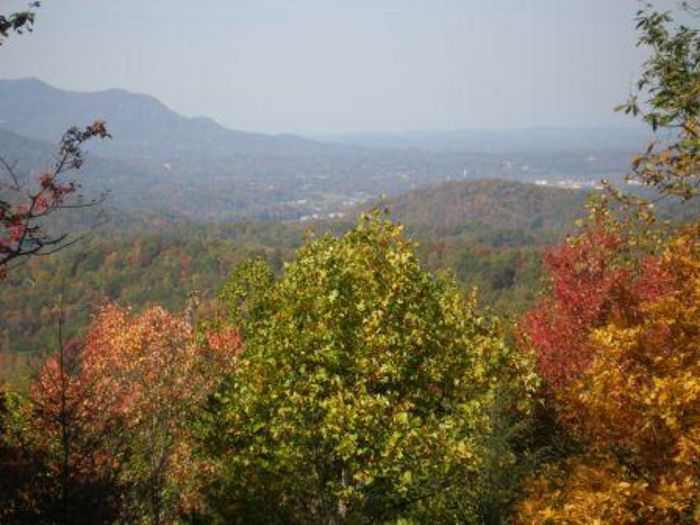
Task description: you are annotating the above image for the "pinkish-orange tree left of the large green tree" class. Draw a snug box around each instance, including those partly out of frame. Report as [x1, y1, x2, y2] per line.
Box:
[26, 305, 240, 523]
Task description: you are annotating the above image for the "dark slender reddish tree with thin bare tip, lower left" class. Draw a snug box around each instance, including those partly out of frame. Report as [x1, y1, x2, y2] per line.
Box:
[27, 314, 128, 523]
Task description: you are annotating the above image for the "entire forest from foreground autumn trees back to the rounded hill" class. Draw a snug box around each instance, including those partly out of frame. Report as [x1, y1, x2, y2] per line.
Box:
[0, 5, 700, 525]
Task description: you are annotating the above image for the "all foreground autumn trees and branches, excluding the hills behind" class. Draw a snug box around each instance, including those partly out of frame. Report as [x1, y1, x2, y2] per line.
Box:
[0, 3, 700, 525]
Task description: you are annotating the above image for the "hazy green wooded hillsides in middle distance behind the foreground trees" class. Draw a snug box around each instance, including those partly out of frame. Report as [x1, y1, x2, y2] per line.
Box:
[0, 181, 572, 360]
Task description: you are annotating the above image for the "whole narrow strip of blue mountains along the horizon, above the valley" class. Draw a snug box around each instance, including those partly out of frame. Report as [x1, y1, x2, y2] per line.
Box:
[0, 78, 648, 157]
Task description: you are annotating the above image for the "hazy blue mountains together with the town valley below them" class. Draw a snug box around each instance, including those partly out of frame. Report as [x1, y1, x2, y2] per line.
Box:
[0, 79, 644, 221]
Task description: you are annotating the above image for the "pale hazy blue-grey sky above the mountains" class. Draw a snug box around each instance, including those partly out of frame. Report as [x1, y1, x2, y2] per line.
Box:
[0, 0, 664, 133]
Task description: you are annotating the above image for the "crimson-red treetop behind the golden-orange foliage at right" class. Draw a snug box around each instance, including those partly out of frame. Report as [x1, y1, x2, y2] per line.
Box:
[520, 215, 665, 389]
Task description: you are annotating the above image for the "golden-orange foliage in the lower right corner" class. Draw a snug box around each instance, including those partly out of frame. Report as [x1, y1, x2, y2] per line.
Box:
[518, 224, 700, 524]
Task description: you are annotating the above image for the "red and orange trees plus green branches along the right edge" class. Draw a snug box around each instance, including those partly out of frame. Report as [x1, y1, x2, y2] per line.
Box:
[516, 10, 700, 524]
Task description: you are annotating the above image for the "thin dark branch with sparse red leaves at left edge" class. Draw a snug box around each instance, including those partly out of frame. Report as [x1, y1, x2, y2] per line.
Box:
[0, 120, 110, 279]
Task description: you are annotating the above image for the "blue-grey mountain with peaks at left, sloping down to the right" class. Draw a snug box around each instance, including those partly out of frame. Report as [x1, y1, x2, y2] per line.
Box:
[0, 78, 344, 157]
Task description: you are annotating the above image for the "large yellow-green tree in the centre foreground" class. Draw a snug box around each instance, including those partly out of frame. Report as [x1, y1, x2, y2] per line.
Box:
[202, 214, 527, 523]
